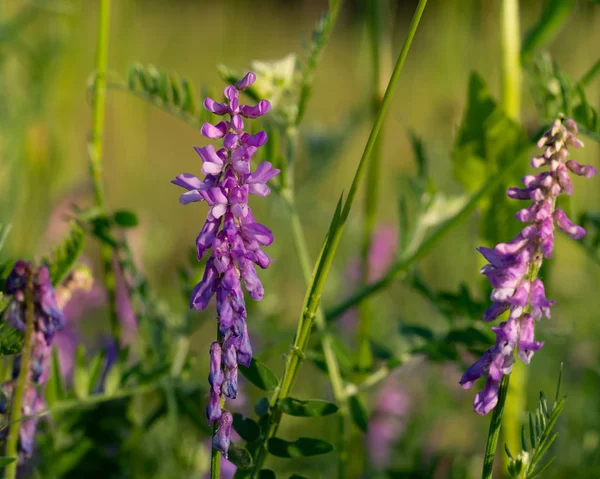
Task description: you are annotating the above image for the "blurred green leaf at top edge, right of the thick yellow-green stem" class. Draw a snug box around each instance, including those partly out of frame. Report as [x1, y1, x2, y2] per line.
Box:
[521, 0, 576, 63]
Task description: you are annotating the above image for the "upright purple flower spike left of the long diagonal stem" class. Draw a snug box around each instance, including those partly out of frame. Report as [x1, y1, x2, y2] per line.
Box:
[172, 73, 279, 455]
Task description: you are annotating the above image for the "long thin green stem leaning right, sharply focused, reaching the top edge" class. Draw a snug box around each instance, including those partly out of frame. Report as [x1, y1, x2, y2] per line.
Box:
[247, 0, 427, 477]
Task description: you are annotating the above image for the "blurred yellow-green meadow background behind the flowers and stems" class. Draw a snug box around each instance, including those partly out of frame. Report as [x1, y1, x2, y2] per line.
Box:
[0, 0, 600, 478]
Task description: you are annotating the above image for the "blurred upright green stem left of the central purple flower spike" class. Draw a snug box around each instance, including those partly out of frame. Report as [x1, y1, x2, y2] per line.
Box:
[89, 0, 121, 348]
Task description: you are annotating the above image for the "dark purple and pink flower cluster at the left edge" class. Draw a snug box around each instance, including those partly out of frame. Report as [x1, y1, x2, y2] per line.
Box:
[0, 260, 64, 460]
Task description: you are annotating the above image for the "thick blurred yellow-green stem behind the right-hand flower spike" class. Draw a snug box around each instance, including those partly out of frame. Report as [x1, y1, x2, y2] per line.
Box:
[501, 0, 527, 467]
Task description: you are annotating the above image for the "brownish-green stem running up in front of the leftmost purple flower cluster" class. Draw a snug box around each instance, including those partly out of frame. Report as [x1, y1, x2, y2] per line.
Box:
[5, 266, 35, 479]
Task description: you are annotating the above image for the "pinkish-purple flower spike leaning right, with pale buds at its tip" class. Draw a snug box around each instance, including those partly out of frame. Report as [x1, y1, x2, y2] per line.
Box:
[460, 119, 596, 414]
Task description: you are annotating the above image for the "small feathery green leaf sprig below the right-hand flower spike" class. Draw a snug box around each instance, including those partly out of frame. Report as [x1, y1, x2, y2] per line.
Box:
[504, 365, 566, 479]
